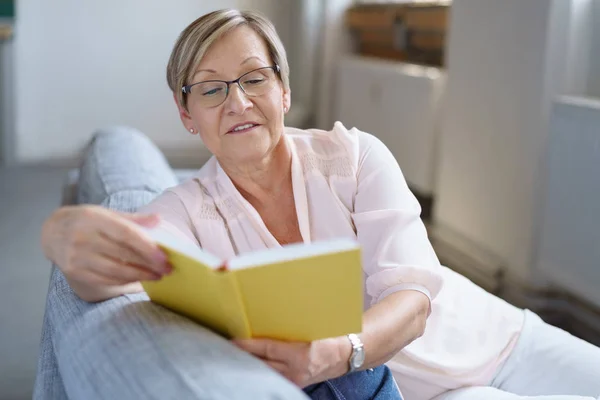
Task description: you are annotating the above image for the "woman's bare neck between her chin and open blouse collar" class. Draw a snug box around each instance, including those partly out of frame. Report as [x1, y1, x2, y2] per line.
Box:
[219, 136, 292, 205]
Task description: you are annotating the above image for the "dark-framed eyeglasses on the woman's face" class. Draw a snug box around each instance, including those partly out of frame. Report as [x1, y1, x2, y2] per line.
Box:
[181, 65, 280, 108]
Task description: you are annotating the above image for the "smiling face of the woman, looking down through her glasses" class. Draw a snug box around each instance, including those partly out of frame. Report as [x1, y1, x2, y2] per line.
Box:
[178, 26, 290, 164]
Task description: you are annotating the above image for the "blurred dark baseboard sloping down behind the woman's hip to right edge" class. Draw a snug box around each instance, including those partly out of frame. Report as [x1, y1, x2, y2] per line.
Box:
[428, 223, 600, 346]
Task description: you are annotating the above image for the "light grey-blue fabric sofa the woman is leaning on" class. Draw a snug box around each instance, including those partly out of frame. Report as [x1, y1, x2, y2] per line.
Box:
[33, 128, 306, 400]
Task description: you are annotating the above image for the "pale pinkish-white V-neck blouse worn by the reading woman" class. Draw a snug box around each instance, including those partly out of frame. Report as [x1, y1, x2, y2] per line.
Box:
[140, 122, 523, 400]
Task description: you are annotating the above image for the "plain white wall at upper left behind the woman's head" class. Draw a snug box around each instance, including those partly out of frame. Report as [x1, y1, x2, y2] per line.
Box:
[14, 0, 291, 162]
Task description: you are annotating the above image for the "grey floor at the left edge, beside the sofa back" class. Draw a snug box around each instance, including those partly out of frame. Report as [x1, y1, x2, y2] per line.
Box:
[0, 167, 66, 400]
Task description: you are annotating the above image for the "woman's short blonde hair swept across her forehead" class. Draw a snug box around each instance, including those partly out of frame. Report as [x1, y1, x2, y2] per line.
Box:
[167, 9, 290, 108]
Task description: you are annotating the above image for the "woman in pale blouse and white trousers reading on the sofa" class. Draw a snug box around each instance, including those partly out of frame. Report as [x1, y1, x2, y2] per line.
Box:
[43, 10, 600, 400]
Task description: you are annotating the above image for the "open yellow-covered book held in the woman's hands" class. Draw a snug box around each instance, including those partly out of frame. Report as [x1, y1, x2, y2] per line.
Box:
[142, 229, 363, 341]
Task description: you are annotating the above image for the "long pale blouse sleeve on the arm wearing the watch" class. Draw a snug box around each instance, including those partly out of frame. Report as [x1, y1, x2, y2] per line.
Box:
[349, 129, 443, 304]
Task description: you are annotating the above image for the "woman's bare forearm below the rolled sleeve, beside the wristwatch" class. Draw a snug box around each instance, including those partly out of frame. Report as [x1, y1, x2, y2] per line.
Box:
[335, 290, 429, 376]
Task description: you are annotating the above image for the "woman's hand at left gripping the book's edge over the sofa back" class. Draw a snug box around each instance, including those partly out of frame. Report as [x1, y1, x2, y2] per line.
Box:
[42, 205, 172, 301]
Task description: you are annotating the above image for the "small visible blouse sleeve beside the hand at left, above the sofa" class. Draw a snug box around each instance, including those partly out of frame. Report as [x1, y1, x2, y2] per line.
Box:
[139, 189, 200, 246]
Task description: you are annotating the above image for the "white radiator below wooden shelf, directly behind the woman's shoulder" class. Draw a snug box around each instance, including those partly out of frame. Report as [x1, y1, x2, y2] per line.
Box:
[334, 56, 445, 196]
